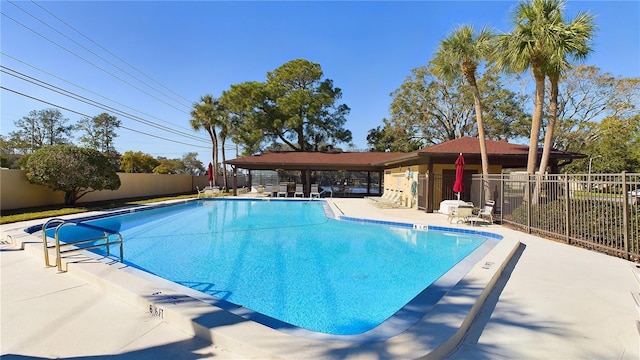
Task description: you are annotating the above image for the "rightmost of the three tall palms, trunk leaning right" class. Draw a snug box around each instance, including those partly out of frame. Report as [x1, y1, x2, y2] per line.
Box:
[540, 13, 595, 177]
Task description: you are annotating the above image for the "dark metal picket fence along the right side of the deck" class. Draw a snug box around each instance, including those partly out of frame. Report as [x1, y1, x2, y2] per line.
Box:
[471, 172, 640, 261]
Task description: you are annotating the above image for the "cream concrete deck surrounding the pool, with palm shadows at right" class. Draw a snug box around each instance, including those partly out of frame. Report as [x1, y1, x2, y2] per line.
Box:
[0, 199, 640, 359]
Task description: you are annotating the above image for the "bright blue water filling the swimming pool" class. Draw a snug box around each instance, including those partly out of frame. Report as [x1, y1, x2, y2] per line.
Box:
[46, 200, 484, 334]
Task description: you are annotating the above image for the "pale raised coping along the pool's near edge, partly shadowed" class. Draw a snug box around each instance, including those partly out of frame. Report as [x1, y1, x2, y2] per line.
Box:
[12, 200, 520, 359]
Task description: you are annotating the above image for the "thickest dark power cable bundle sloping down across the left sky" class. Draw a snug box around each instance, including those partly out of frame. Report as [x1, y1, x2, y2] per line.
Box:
[0, 65, 208, 142]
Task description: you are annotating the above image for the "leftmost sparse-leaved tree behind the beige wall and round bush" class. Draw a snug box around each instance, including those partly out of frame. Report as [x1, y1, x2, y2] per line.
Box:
[9, 108, 73, 153]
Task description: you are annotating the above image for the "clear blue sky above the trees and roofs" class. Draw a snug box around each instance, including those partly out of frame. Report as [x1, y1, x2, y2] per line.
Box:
[0, 0, 640, 163]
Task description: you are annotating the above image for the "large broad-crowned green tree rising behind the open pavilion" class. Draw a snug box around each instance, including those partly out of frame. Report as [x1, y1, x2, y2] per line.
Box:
[222, 59, 351, 151]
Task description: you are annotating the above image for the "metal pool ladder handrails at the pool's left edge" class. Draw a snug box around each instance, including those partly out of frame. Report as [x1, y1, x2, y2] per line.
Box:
[42, 219, 123, 271]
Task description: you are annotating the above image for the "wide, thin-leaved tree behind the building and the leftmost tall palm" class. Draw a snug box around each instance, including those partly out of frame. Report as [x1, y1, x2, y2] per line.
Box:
[383, 66, 527, 146]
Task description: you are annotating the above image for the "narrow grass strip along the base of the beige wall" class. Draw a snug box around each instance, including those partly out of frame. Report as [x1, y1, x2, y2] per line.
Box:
[0, 194, 205, 224]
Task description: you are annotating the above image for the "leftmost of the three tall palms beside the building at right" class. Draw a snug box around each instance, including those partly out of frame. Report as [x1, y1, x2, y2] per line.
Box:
[432, 25, 494, 200]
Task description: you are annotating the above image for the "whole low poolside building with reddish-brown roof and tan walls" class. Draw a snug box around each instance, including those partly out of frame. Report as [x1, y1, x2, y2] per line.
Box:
[226, 137, 585, 211]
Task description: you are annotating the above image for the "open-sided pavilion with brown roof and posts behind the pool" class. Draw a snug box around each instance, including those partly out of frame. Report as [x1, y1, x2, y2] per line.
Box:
[225, 151, 404, 196]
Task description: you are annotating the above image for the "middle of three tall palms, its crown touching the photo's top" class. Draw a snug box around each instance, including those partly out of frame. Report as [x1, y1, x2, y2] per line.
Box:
[494, 0, 564, 175]
